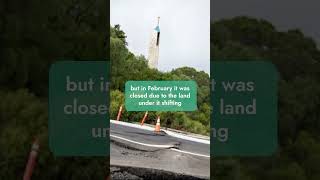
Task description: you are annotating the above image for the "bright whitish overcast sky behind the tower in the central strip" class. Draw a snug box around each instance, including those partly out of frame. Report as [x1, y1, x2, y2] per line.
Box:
[110, 0, 210, 73]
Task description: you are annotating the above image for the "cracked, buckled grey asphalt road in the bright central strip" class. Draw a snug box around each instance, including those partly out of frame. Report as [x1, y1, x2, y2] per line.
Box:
[110, 123, 210, 179]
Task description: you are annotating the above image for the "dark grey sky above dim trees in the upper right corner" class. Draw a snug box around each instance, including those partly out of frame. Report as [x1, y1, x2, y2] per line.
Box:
[211, 0, 320, 44]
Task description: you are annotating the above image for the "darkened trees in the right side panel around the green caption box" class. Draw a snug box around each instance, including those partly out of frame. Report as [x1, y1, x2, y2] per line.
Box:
[211, 17, 320, 180]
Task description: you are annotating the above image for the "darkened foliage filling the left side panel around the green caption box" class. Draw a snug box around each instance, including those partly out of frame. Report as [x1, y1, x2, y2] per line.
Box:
[0, 0, 109, 180]
